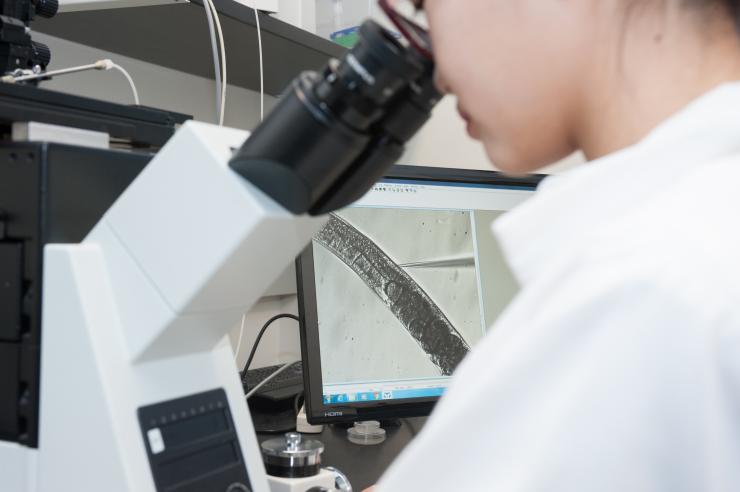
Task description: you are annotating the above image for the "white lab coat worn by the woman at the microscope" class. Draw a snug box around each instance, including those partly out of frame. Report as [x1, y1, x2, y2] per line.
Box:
[379, 83, 740, 492]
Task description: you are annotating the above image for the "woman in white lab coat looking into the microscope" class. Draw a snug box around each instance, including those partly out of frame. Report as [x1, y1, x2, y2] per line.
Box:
[378, 0, 740, 492]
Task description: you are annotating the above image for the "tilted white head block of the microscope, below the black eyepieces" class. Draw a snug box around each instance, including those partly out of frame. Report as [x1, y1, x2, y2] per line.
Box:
[84, 122, 325, 362]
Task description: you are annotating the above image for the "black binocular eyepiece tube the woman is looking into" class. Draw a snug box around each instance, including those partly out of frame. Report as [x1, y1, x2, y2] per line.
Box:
[230, 21, 441, 215]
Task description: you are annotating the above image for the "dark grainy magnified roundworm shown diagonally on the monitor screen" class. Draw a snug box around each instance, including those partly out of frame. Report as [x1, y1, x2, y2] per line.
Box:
[314, 214, 470, 375]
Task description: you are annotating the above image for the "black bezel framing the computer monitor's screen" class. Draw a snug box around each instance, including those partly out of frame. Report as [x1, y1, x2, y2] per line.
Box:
[296, 166, 544, 424]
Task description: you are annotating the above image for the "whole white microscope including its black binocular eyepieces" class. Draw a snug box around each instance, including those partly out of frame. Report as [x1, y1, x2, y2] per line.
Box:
[0, 5, 441, 492]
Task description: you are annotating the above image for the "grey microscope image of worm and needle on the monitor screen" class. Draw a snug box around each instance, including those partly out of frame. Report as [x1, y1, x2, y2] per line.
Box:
[314, 207, 498, 384]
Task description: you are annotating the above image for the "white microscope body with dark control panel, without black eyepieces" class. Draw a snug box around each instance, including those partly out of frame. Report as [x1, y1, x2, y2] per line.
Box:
[30, 122, 324, 492]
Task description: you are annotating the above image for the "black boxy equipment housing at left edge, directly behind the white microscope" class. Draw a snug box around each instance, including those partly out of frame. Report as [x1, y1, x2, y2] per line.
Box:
[0, 143, 152, 447]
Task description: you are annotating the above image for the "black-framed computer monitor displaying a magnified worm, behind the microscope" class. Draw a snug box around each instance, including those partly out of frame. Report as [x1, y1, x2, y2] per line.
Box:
[296, 166, 541, 423]
